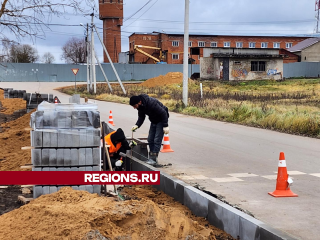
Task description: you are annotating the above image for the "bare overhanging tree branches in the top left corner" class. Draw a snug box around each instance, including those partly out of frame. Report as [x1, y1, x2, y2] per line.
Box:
[0, 0, 95, 40]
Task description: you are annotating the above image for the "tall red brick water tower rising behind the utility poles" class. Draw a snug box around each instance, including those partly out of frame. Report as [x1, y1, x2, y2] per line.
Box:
[99, 0, 123, 63]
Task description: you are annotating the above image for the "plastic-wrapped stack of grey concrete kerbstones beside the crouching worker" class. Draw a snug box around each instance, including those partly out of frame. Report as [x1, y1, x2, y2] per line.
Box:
[30, 102, 101, 198]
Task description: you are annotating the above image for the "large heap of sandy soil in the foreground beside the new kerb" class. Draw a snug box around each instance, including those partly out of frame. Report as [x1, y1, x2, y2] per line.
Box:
[0, 187, 233, 240]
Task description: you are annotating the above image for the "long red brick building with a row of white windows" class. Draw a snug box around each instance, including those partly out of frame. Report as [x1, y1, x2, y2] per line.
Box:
[129, 32, 310, 64]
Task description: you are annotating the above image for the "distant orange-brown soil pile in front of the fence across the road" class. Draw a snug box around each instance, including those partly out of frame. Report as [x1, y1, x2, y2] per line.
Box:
[141, 72, 190, 87]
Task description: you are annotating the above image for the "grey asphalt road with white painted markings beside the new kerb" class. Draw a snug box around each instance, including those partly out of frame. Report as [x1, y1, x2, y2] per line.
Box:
[0, 82, 320, 240]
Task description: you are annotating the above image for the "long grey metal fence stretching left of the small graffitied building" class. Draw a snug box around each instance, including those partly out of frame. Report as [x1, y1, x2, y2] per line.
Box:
[0, 63, 200, 82]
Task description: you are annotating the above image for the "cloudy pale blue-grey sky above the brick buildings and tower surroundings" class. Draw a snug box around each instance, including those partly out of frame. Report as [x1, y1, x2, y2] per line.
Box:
[2, 0, 316, 63]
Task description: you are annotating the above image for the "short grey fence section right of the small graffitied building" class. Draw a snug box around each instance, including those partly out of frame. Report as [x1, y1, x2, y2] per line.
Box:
[283, 62, 320, 78]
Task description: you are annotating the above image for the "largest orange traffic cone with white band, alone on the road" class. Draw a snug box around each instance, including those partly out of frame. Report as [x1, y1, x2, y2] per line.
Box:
[268, 152, 298, 197]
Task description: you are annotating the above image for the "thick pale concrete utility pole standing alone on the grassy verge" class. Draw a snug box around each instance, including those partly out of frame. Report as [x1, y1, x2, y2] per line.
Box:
[182, 0, 189, 107]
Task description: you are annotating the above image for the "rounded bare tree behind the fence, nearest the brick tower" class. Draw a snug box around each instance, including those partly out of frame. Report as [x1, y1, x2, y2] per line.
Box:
[61, 37, 87, 63]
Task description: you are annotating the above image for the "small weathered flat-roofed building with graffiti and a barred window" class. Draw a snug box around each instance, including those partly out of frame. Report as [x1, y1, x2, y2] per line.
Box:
[198, 48, 285, 80]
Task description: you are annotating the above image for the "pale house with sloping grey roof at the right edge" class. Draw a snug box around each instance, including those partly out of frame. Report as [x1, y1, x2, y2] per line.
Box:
[287, 38, 320, 62]
